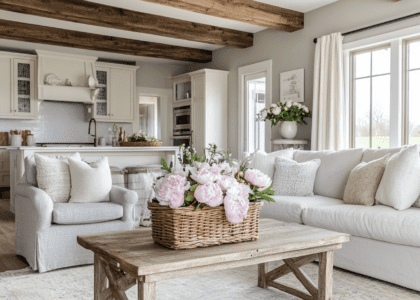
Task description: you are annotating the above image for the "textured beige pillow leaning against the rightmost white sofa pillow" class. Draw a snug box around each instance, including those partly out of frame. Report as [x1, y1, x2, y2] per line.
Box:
[343, 154, 390, 206]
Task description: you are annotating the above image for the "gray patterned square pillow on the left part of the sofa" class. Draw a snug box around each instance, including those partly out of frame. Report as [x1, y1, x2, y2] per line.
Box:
[273, 157, 321, 196]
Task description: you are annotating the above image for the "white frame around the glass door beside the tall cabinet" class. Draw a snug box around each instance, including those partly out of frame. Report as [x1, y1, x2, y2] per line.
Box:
[238, 59, 273, 159]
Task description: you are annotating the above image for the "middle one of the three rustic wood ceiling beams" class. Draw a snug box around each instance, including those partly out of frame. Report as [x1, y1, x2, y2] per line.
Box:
[0, 0, 253, 48]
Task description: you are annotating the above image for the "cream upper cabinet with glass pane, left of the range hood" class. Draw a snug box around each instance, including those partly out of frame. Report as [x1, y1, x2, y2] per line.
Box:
[0, 52, 38, 119]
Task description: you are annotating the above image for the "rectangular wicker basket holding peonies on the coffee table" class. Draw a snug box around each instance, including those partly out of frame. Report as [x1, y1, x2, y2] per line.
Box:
[148, 201, 263, 249]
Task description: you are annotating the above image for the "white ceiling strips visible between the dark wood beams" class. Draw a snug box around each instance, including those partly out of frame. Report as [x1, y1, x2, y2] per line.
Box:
[0, 0, 338, 64]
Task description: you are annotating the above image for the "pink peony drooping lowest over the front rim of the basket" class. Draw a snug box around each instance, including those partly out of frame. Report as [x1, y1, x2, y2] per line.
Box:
[224, 184, 251, 224]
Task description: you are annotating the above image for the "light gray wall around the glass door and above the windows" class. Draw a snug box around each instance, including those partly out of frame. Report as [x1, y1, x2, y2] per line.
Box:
[186, 0, 420, 154]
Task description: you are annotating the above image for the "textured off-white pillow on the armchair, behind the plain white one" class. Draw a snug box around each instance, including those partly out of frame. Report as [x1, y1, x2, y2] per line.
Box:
[32, 152, 80, 203]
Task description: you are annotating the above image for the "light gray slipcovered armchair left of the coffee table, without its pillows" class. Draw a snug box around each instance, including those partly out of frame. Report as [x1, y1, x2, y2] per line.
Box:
[15, 161, 138, 273]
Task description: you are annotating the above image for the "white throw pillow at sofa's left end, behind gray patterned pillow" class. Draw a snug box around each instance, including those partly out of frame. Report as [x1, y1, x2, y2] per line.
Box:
[249, 148, 293, 179]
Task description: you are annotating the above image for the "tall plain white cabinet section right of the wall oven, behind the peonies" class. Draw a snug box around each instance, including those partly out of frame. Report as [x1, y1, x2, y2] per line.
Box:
[189, 69, 229, 155]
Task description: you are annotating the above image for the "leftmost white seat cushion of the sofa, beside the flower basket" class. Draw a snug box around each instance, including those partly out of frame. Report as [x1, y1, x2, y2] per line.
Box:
[260, 196, 343, 224]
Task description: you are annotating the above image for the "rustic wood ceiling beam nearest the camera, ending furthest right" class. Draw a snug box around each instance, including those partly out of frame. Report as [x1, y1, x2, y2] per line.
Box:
[139, 0, 304, 32]
